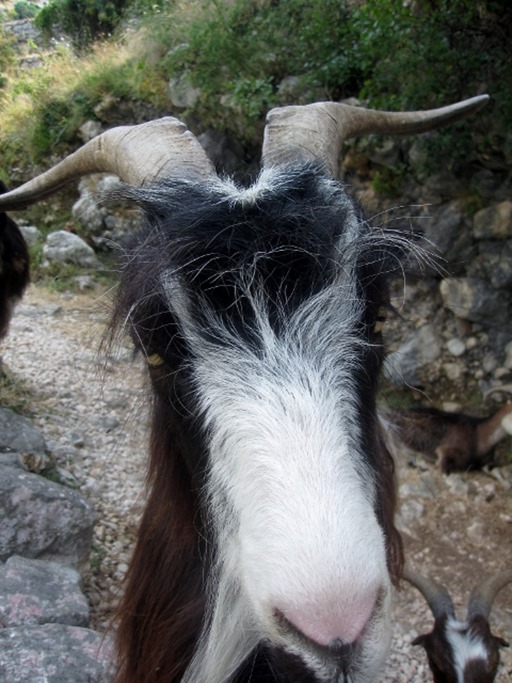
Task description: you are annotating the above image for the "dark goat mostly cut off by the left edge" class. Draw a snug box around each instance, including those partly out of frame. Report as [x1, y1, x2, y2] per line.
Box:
[0, 180, 30, 339]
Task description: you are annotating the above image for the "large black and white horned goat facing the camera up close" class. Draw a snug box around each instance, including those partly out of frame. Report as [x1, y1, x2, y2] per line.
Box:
[0, 96, 487, 683]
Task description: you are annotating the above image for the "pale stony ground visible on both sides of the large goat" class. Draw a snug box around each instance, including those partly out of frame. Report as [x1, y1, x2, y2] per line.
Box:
[0, 280, 512, 683]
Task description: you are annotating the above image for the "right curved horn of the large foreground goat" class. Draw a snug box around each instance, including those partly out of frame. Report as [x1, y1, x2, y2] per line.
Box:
[262, 95, 489, 177]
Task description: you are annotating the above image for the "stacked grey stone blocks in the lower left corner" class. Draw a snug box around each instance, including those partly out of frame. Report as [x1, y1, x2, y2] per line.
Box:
[0, 408, 113, 683]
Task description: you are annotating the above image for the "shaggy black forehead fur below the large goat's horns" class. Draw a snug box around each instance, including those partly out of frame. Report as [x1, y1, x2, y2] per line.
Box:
[114, 165, 409, 351]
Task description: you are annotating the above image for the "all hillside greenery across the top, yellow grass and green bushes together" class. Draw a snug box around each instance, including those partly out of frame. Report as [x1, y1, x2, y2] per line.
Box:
[0, 0, 512, 176]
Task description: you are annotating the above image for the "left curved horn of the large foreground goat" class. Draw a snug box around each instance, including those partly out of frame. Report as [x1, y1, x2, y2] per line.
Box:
[0, 116, 215, 211]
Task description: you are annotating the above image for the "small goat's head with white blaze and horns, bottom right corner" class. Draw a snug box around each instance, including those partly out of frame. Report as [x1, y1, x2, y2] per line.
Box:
[404, 568, 512, 683]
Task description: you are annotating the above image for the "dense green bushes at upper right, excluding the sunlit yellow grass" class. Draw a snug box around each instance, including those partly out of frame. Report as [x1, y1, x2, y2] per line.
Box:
[153, 0, 512, 168]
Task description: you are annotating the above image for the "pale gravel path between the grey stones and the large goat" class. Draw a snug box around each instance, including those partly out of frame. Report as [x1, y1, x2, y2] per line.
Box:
[2, 287, 148, 630]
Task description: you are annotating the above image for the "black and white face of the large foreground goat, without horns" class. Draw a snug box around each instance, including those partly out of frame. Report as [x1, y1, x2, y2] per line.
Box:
[115, 167, 404, 683]
